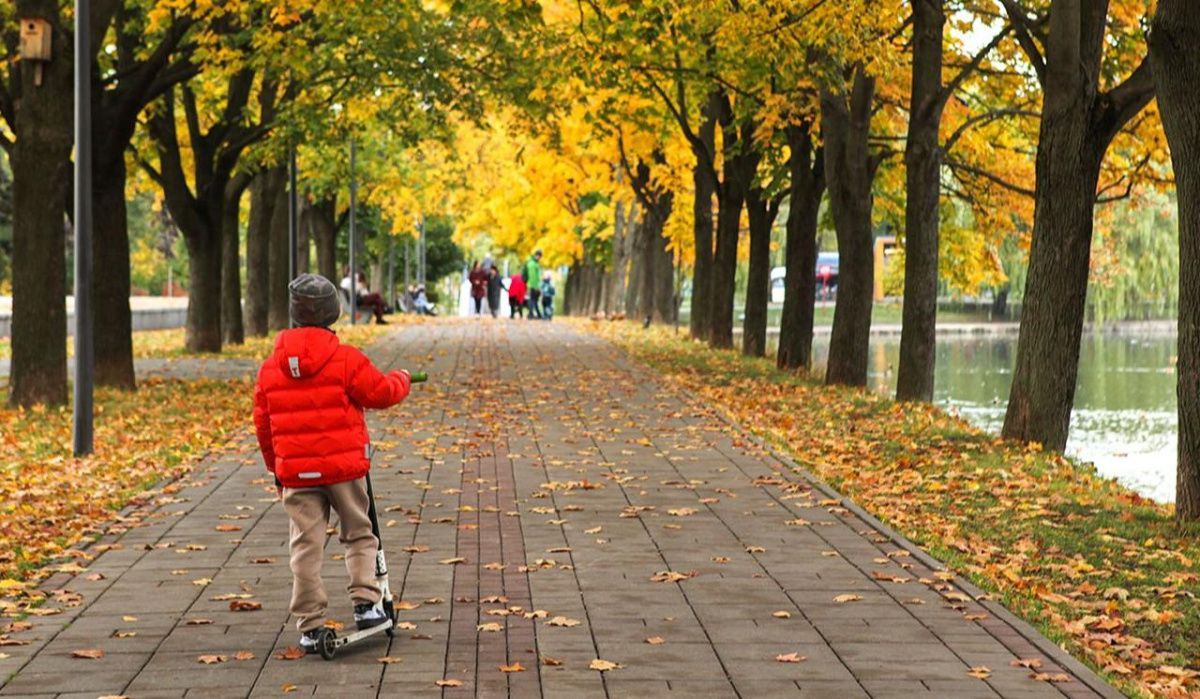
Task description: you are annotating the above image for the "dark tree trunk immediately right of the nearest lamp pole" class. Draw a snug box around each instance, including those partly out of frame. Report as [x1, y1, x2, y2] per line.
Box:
[91, 157, 137, 390]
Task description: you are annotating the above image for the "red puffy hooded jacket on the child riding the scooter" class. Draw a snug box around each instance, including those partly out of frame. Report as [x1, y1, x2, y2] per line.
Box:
[254, 328, 409, 488]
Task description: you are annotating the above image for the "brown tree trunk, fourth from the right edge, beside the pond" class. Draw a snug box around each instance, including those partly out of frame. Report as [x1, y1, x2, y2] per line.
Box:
[821, 67, 877, 386]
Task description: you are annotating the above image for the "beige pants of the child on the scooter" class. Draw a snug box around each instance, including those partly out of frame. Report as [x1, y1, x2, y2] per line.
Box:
[283, 478, 379, 632]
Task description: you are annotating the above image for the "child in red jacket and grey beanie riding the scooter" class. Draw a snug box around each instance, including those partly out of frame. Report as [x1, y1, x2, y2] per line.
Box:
[254, 274, 412, 652]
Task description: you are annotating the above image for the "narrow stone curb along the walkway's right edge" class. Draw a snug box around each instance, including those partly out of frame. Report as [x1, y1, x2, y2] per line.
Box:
[688, 405, 1126, 699]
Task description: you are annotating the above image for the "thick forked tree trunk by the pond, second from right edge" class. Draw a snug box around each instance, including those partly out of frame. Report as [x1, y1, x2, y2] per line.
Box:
[1003, 0, 1154, 449]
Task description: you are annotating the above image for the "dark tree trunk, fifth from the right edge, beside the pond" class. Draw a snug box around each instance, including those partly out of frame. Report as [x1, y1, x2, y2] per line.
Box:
[775, 124, 824, 370]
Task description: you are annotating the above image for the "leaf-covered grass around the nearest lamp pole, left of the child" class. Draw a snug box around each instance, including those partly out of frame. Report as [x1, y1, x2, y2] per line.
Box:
[0, 380, 252, 583]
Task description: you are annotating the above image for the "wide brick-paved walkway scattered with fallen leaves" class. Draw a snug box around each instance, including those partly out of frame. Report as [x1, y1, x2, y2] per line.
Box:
[0, 321, 1111, 699]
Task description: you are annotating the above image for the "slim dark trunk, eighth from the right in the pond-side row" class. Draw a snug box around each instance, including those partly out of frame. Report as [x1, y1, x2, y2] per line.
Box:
[688, 92, 720, 340]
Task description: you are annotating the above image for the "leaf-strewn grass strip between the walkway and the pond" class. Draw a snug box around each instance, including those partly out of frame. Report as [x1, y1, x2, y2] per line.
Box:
[590, 322, 1200, 697]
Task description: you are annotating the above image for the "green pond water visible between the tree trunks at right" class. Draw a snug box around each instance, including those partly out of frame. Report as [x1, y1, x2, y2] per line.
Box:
[814, 333, 1177, 502]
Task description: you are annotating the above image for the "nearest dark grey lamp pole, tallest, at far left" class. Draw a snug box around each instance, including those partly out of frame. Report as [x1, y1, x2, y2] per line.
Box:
[73, 0, 96, 456]
